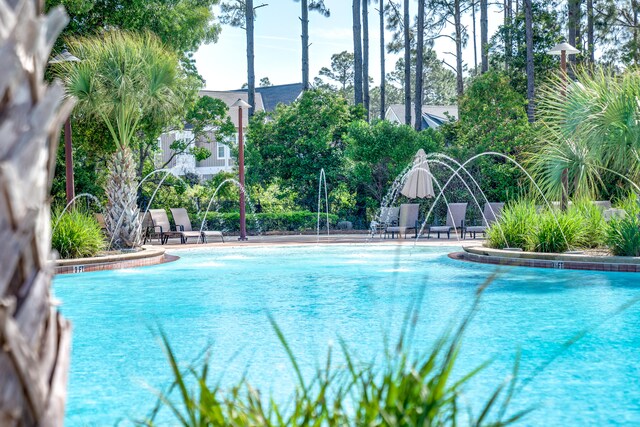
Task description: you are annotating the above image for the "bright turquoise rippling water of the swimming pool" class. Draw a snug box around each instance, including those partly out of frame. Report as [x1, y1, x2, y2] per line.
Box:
[54, 245, 640, 426]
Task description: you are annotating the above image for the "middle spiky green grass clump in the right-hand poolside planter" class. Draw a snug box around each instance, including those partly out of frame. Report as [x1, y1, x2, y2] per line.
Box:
[528, 209, 585, 253]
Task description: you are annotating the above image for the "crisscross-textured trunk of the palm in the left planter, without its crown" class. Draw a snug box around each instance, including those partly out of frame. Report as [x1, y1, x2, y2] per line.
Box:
[104, 147, 141, 248]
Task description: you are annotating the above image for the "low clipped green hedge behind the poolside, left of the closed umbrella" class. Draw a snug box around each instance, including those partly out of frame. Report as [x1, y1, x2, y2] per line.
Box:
[198, 211, 338, 233]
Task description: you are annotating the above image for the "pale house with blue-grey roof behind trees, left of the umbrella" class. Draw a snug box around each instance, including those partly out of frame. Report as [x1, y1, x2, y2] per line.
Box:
[155, 83, 302, 179]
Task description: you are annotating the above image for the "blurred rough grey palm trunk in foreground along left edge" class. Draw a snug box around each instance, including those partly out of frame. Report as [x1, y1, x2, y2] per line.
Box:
[0, 0, 73, 426]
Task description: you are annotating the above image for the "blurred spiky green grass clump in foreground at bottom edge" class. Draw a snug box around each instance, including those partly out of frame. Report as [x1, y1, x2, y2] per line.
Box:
[137, 279, 530, 427]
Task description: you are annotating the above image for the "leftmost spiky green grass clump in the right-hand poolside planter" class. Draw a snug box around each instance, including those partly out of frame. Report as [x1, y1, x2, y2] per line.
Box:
[487, 200, 537, 250]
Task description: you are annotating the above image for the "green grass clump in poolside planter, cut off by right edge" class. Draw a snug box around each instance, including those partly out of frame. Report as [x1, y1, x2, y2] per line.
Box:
[606, 194, 640, 256]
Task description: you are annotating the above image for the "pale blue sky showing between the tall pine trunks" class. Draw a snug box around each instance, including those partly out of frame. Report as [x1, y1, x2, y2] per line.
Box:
[195, 0, 502, 90]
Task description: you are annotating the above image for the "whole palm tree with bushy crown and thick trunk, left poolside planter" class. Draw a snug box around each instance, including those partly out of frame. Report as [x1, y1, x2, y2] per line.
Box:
[56, 31, 182, 248]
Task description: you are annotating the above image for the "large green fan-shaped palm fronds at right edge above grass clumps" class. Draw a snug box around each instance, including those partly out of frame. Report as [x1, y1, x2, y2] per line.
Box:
[530, 68, 640, 198]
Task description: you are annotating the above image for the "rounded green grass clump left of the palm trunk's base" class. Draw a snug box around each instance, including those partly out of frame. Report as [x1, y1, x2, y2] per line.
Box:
[51, 209, 105, 259]
